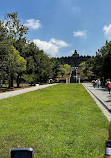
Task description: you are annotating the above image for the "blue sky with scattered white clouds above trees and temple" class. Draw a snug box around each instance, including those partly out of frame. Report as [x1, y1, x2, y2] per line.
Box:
[0, 0, 111, 57]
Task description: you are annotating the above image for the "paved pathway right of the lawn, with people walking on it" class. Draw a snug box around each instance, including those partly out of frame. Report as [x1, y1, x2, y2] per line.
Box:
[83, 83, 111, 121]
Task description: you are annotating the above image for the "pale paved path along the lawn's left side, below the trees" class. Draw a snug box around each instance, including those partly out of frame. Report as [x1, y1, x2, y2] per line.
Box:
[0, 83, 56, 100]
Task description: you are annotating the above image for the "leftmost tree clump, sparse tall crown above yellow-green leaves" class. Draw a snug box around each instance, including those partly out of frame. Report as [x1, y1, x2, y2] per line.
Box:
[0, 13, 28, 87]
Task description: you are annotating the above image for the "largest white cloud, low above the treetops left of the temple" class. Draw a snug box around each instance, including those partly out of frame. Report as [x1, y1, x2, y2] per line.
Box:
[33, 38, 68, 57]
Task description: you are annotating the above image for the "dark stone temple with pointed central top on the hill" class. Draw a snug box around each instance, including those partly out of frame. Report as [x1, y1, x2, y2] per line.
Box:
[57, 50, 91, 67]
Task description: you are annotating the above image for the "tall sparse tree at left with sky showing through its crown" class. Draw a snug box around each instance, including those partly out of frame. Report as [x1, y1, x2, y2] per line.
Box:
[4, 12, 28, 86]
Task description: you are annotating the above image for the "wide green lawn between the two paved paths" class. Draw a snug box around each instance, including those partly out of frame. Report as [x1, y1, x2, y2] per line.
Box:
[0, 84, 109, 158]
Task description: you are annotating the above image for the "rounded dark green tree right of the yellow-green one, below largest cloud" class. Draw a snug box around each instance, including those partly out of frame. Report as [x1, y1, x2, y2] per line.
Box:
[22, 42, 51, 83]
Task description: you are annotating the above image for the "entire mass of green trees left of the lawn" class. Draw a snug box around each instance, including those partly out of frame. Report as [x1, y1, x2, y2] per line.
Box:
[0, 12, 57, 87]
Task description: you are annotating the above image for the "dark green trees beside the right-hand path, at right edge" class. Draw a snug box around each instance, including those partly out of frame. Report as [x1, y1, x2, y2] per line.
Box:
[85, 41, 111, 83]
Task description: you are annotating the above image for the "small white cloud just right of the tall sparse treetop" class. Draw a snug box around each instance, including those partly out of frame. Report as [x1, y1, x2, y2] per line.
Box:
[24, 19, 41, 29]
